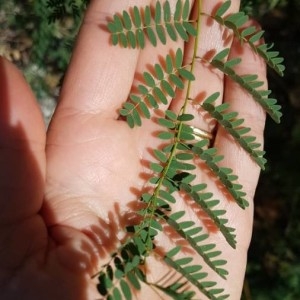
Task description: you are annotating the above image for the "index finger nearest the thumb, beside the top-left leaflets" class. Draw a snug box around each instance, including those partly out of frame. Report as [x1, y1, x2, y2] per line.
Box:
[56, 0, 149, 118]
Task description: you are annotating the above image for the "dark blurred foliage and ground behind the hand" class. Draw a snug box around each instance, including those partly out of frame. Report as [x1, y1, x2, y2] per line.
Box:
[0, 0, 300, 300]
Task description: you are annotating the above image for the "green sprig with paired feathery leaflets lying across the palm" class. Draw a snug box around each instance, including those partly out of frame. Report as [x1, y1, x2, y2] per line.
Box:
[98, 0, 284, 300]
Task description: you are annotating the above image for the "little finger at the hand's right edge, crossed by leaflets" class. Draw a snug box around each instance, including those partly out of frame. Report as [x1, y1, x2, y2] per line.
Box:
[215, 34, 267, 210]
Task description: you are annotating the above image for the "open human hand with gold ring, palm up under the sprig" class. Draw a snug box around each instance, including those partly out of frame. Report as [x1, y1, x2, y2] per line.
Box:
[0, 0, 266, 300]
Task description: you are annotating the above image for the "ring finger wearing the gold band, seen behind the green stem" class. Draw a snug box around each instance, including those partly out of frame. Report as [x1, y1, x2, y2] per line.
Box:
[171, 0, 240, 132]
